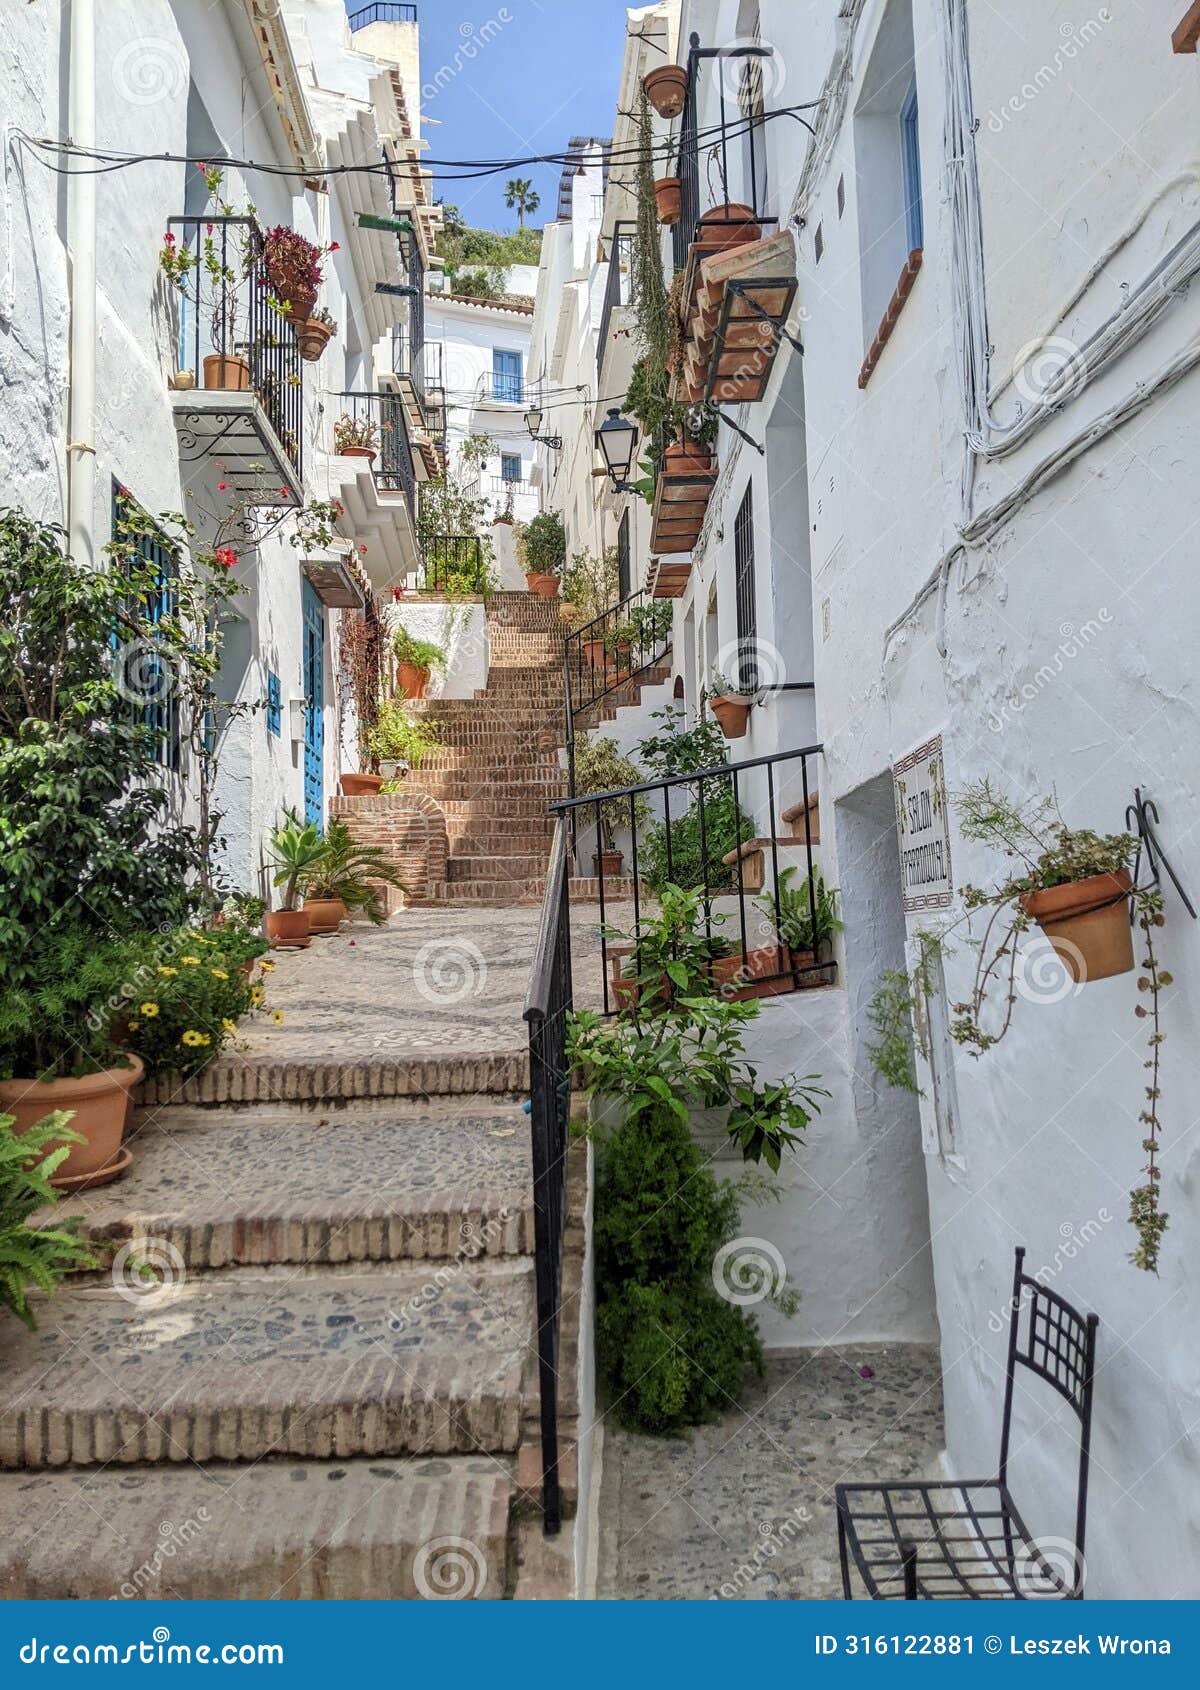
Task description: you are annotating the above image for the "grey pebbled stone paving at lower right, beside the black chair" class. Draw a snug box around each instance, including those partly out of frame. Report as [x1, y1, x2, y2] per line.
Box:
[597, 1344, 943, 1600]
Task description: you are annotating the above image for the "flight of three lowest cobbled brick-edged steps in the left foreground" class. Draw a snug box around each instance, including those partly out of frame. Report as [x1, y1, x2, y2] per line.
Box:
[0, 1097, 581, 1599]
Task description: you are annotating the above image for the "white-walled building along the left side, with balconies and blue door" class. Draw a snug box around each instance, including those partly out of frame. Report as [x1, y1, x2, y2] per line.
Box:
[0, 0, 438, 891]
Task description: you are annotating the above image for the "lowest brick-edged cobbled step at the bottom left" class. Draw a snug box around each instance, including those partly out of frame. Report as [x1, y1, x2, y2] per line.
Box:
[0, 1455, 515, 1602]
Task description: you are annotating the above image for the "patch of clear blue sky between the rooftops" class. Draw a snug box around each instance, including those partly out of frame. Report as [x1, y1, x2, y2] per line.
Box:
[356, 0, 625, 230]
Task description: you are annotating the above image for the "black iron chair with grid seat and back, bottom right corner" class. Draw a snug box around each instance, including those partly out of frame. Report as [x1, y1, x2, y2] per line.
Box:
[837, 1249, 1100, 1602]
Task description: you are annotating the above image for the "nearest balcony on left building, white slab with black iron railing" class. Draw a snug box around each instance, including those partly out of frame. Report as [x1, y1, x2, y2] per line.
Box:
[166, 216, 304, 505]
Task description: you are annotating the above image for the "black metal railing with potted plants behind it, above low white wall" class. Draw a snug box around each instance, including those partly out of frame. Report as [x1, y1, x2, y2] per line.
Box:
[549, 745, 833, 1014]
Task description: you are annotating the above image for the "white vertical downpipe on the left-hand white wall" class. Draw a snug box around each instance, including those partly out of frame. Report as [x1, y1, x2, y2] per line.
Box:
[66, 0, 96, 564]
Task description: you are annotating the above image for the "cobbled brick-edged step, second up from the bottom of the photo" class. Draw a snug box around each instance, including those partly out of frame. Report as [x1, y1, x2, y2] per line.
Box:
[0, 1262, 534, 1469]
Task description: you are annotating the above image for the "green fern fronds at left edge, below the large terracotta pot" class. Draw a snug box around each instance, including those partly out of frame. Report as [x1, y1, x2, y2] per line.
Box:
[0, 1110, 96, 1330]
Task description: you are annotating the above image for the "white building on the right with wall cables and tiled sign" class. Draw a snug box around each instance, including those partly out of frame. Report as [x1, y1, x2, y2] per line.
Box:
[544, 0, 1200, 1597]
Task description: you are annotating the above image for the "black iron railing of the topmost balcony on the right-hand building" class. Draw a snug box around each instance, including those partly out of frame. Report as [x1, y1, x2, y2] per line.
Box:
[671, 30, 777, 270]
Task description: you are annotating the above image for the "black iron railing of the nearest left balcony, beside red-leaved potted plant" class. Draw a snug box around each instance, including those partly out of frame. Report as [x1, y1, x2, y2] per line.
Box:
[167, 216, 304, 480]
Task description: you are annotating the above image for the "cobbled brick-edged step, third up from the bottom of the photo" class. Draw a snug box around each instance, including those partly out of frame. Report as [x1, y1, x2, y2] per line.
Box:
[50, 1100, 532, 1273]
